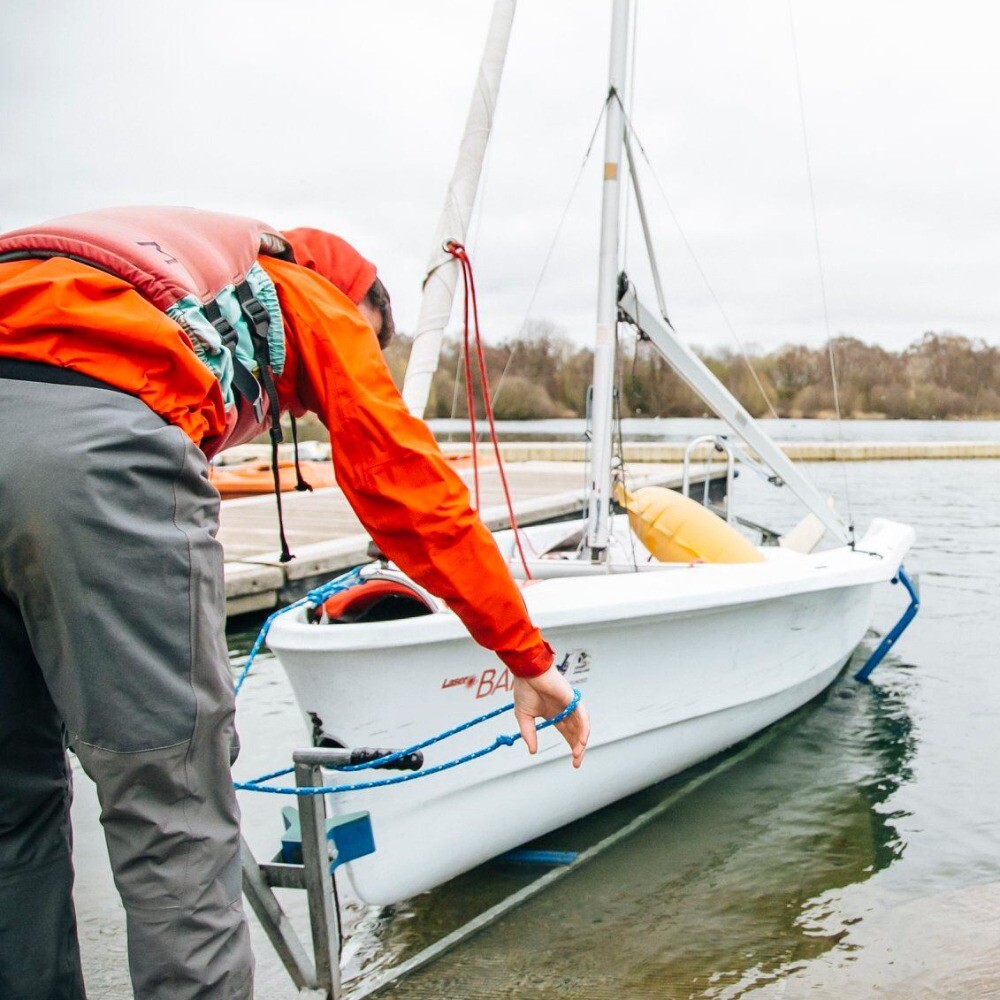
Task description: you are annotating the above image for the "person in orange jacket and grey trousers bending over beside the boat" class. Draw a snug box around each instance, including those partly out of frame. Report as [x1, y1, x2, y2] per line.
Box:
[0, 208, 589, 1000]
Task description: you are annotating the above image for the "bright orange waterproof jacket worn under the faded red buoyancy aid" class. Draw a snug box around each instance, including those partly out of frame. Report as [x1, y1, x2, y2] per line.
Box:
[0, 256, 553, 677]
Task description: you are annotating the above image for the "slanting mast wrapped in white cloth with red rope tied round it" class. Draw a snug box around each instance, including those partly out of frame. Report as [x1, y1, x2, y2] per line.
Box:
[403, 0, 517, 417]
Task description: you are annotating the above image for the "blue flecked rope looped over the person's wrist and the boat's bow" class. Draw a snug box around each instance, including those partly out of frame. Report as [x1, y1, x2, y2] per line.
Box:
[233, 569, 580, 795]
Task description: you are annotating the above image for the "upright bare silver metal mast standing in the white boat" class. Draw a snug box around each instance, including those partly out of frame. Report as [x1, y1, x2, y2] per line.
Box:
[587, 0, 629, 560]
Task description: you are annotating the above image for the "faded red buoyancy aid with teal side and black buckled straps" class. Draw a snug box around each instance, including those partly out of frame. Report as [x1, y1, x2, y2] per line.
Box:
[0, 206, 294, 439]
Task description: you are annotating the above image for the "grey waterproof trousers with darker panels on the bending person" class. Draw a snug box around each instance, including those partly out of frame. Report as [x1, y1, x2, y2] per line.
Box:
[0, 373, 253, 1000]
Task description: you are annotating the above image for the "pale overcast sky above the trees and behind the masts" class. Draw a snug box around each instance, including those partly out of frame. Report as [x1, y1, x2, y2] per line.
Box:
[0, 0, 1000, 348]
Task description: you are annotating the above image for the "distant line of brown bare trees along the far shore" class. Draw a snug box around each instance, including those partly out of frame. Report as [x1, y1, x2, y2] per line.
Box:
[387, 322, 1000, 420]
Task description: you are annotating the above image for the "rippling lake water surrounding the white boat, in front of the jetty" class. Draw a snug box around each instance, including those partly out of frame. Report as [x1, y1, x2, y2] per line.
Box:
[75, 458, 1000, 1000]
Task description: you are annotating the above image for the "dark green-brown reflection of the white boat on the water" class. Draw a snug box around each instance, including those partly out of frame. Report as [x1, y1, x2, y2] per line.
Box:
[347, 652, 915, 1000]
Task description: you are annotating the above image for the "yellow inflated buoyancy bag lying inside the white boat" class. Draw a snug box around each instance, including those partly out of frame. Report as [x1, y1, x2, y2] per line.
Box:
[615, 485, 764, 563]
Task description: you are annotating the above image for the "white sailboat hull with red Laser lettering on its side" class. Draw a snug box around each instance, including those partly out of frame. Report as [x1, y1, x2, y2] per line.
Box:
[270, 521, 913, 904]
